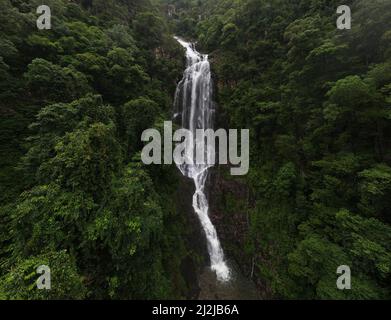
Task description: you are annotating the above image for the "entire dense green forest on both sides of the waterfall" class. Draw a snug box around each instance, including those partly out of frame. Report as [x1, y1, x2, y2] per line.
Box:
[0, 0, 391, 299]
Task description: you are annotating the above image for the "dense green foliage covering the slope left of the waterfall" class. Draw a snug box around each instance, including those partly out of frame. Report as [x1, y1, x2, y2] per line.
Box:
[0, 0, 194, 299]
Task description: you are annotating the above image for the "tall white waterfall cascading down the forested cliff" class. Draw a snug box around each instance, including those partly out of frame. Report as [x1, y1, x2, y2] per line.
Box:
[174, 38, 230, 281]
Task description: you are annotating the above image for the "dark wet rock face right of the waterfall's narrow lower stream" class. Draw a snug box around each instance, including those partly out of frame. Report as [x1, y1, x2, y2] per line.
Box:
[207, 166, 273, 299]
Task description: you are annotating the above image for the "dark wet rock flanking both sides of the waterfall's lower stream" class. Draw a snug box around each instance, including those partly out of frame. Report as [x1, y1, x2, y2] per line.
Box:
[176, 164, 264, 300]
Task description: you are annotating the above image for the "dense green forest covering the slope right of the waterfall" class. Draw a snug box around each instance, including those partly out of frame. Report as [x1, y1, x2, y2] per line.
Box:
[170, 0, 391, 299]
